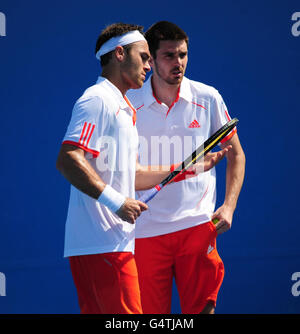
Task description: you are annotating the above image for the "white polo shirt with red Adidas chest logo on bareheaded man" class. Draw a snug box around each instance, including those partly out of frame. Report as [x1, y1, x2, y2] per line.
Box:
[127, 77, 236, 238]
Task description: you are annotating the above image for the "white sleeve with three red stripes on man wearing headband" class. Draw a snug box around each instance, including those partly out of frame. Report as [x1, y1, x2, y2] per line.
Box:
[63, 96, 109, 158]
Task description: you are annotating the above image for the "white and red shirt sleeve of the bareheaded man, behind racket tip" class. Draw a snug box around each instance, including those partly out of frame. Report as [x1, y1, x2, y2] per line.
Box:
[211, 90, 237, 144]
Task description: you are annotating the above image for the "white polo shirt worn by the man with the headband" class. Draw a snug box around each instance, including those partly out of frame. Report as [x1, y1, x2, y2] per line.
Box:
[63, 77, 138, 257]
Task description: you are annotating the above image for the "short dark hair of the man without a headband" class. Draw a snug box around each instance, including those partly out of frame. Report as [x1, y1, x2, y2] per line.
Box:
[145, 21, 189, 58]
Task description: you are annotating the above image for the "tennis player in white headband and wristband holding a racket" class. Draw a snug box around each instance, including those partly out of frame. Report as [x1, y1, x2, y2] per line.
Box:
[57, 23, 230, 314]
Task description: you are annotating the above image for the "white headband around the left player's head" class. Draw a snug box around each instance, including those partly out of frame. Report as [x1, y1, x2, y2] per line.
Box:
[96, 30, 146, 60]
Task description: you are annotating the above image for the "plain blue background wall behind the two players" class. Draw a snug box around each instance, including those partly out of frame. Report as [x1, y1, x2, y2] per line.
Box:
[0, 0, 300, 313]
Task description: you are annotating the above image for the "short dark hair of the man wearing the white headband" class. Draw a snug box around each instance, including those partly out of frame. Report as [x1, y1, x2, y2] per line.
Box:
[95, 22, 144, 66]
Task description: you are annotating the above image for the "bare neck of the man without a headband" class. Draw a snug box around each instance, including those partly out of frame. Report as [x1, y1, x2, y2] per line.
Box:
[151, 75, 180, 107]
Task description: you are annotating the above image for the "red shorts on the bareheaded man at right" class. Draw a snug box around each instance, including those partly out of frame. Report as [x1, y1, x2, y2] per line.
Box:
[135, 222, 224, 314]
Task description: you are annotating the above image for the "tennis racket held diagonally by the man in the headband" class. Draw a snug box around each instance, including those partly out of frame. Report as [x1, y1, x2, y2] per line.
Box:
[139, 118, 238, 203]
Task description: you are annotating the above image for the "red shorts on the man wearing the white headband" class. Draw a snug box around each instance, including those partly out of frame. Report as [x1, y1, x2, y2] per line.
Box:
[69, 252, 142, 314]
